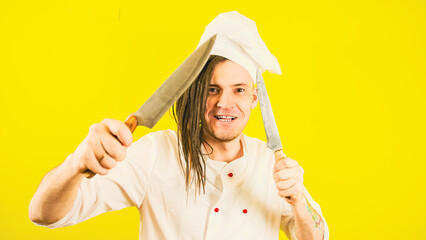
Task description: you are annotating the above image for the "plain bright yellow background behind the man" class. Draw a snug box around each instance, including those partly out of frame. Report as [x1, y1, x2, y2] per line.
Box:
[0, 0, 426, 240]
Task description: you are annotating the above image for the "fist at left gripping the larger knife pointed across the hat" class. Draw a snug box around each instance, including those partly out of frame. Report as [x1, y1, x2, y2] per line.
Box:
[67, 118, 133, 175]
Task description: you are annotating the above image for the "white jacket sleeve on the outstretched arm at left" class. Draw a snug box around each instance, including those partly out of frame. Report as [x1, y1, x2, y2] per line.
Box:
[36, 133, 158, 228]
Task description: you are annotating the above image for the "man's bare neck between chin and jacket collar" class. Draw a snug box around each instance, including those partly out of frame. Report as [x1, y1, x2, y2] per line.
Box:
[205, 134, 244, 163]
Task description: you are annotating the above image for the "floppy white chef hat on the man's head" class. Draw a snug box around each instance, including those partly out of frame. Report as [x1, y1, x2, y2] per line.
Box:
[197, 11, 281, 82]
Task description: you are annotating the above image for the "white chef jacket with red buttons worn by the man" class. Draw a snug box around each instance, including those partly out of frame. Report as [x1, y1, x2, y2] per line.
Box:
[37, 130, 329, 240]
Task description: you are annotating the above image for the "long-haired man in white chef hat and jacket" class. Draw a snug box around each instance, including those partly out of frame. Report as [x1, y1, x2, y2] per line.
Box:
[30, 12, 328, 239]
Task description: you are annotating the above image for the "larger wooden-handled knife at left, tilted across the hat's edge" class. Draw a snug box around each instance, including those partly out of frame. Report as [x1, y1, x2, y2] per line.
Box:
[83, 35, 216, 178]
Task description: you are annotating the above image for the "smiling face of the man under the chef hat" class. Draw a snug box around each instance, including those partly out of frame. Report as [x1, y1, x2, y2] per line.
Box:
[204, 60, 258, 142]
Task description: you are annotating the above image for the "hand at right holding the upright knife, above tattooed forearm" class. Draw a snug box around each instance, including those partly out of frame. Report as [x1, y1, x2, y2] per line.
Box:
[274, 157, 305, 206]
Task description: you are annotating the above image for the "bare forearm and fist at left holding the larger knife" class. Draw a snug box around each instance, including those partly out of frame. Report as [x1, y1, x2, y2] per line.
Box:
[29, 117, 136, 225]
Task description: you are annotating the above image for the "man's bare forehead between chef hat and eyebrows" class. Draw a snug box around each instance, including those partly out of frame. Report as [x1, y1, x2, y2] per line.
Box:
[210, 60, 253, 86]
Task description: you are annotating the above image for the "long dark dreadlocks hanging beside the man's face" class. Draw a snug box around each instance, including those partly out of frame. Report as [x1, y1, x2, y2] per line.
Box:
[173, 55, 227, 194]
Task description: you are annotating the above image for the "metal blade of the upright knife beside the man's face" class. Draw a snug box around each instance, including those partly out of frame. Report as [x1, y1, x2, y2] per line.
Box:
[257, 69, 283, 152]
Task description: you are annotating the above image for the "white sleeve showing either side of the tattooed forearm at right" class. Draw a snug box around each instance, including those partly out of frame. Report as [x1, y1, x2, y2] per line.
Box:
[281, 187, 329, 240]
